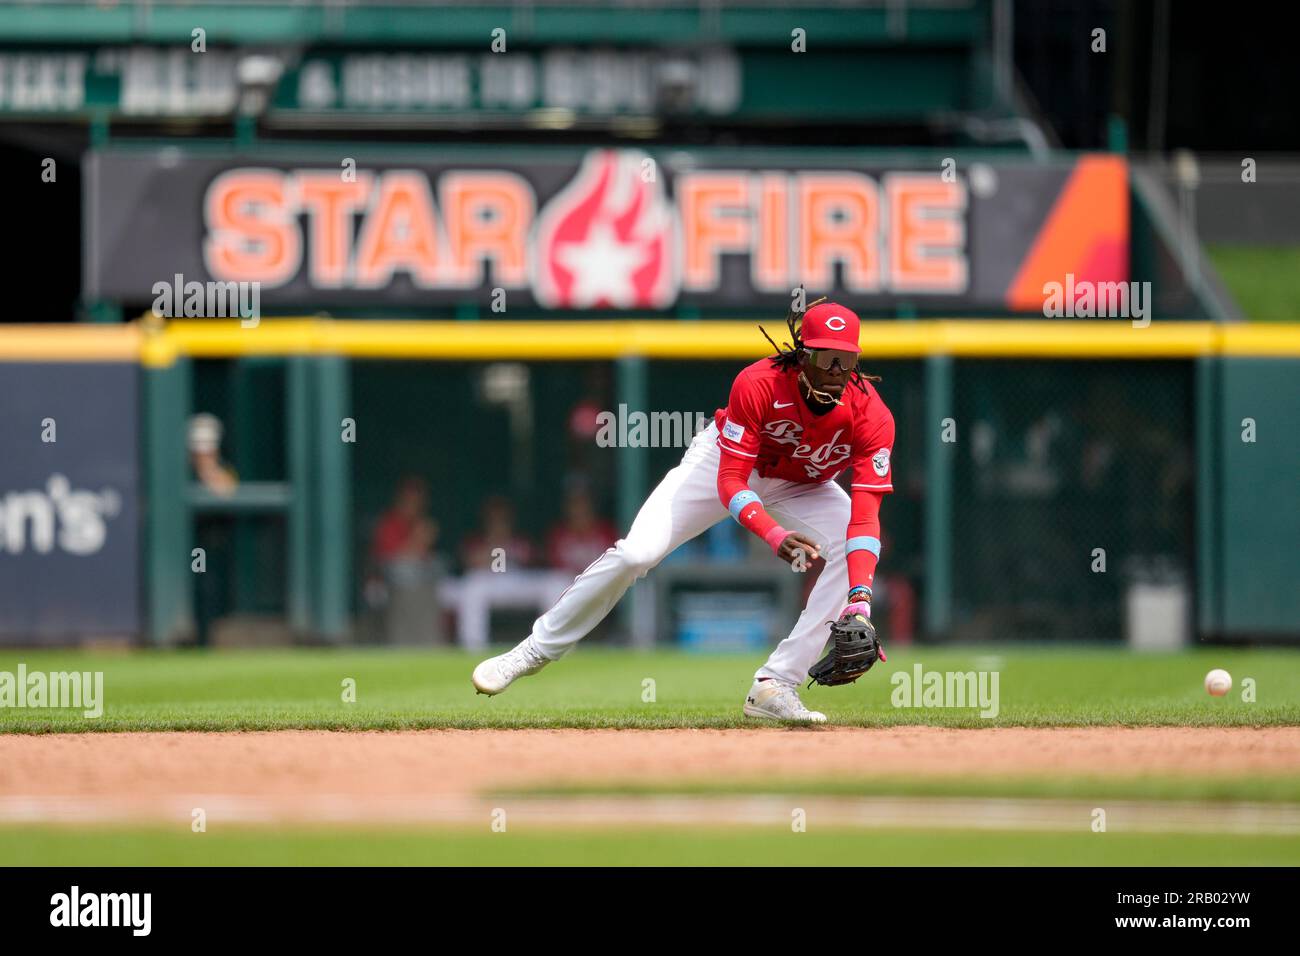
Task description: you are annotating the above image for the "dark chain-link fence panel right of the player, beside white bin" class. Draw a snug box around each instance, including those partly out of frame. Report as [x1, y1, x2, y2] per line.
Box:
[950, 362, 1195, 640]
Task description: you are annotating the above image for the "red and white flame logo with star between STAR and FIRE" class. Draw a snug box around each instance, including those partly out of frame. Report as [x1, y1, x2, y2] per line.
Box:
[533, 150, 680, 308]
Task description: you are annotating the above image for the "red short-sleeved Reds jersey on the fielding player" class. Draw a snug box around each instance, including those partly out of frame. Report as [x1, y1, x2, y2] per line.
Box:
[714, 359, 894, 493]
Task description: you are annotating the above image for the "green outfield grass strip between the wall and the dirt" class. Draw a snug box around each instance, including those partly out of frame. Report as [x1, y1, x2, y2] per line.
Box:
[0, 646, 1300, 732]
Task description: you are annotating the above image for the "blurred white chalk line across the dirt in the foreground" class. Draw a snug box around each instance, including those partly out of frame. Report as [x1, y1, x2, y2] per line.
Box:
[0, 793, 1300, 835]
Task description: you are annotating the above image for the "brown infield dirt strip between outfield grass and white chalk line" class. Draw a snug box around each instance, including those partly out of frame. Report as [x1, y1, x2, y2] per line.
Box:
[0, 727, 1300, 822]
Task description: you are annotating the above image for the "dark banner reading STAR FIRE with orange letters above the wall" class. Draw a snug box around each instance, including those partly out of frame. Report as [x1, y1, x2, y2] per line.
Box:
[86, 147, 1128, 317]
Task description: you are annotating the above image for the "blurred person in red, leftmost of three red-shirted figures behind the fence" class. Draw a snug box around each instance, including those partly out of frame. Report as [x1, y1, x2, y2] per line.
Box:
[367, 476, 446, 645]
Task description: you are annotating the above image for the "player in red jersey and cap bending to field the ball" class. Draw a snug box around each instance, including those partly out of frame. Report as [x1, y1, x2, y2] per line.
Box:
[473, 302, 894, 723]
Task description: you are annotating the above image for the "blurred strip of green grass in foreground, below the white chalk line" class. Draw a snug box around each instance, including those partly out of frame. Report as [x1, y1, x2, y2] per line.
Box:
[0, 826, 1300, 866]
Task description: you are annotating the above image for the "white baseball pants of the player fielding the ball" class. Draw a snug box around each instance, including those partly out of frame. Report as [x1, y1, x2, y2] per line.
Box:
[533, 424, 849, 684]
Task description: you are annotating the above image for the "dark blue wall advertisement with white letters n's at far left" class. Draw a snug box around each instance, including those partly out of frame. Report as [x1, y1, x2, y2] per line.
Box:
[0, 356, 139, 644]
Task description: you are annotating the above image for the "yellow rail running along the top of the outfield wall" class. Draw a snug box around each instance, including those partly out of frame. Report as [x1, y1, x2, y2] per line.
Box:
[0, 319, 1300, 367]
